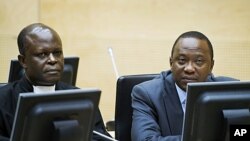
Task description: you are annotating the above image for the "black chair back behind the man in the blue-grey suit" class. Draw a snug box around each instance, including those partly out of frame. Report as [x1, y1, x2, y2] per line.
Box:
[114, 74, 159, 141]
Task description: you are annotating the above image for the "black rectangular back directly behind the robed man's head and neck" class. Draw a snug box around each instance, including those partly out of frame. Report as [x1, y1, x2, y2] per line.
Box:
[8, 56, 80, 86]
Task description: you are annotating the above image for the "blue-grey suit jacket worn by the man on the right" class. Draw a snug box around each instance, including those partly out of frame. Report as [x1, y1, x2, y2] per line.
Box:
[131, 71, 235, 141]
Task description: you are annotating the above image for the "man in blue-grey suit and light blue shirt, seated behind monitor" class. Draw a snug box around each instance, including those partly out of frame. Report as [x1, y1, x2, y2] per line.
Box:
[131, 31, 235, 141]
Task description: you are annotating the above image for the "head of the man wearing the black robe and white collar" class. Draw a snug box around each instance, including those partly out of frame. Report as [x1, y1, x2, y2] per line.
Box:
[17, 23, 64, 86]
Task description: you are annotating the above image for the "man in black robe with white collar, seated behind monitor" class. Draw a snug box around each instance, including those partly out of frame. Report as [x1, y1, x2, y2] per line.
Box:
[0, 23, 110, 141]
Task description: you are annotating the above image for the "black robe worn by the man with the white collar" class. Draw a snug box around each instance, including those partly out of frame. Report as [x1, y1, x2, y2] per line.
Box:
[0, 77, 110, 141]
